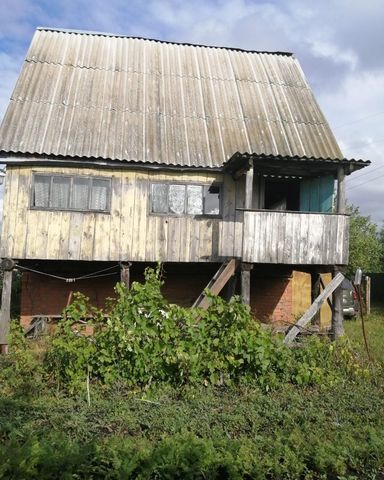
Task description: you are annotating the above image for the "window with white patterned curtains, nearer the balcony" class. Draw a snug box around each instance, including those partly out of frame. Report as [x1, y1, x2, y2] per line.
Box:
[151, 183, 221, 215]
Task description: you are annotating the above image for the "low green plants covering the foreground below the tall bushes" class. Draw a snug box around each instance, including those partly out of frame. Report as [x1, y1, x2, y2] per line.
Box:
[0, 383, 384, 480]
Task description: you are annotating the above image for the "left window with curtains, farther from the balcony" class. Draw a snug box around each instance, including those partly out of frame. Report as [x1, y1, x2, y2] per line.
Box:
[31, 174, 111, 212]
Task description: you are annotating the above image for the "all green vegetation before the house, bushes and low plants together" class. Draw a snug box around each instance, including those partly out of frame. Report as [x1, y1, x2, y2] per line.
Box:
[0, 271, 384, 480]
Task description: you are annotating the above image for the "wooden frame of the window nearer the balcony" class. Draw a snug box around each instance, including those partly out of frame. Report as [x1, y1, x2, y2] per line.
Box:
[148, 180, 223, 219]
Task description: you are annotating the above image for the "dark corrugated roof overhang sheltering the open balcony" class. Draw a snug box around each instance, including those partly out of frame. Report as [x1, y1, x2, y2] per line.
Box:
[223, 152, 371, 178]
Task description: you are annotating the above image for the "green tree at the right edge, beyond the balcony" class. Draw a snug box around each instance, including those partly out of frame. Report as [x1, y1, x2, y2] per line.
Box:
[347, 205, 384, 278]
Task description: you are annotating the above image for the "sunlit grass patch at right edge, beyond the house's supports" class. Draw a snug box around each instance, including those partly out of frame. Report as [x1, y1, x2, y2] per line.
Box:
[344, 309, 384, 367]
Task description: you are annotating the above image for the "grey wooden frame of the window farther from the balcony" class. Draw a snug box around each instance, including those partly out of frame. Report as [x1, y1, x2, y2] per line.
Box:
[29, 171, 112, 214]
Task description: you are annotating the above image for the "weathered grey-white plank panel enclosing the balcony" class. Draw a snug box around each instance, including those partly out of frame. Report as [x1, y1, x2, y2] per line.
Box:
[243, 211, 349, 265]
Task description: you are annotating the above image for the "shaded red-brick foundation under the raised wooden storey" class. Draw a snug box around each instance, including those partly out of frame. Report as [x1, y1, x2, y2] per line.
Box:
[21, 262, 331, 328]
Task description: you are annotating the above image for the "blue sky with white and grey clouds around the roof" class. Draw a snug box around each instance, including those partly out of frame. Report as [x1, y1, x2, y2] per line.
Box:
[0, 0, 384, 226]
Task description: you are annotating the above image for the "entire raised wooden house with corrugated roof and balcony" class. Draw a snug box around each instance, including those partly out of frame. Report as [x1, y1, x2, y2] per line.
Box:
[0, 28, 369, 343]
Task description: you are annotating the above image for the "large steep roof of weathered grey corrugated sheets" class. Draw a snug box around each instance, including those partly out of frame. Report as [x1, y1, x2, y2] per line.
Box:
[0, 28, 342, 167]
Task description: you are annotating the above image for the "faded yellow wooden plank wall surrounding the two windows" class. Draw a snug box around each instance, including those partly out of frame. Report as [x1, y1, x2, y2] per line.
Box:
[1, 167, 242, 262]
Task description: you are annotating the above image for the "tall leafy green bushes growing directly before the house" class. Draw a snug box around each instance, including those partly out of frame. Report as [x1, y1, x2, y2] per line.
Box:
[46, 269, 366, 392]
